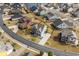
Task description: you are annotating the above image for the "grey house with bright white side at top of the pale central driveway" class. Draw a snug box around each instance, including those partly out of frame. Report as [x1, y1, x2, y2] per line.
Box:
[32, 24, 47, 37]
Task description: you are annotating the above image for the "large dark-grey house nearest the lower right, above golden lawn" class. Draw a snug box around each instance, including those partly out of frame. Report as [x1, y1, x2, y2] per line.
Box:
[59, 29, 78, 45]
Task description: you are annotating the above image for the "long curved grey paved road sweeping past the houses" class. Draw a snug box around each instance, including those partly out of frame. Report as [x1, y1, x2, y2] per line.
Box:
[0, 5, 79, 56]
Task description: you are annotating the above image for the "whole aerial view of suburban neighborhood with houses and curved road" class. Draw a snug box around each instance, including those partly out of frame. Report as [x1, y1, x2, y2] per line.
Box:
[0, 3, 79, 56]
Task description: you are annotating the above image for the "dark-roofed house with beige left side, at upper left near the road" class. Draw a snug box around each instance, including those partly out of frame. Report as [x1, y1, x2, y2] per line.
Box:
[3, 9, 23, 20]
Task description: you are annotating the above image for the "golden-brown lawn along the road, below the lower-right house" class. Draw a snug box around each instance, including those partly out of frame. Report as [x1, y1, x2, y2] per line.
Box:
[45, 39, 79, 53]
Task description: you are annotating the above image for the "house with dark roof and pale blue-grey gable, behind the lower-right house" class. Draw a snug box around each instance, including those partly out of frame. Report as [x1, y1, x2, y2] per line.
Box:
[52, 17, 74, 29]
